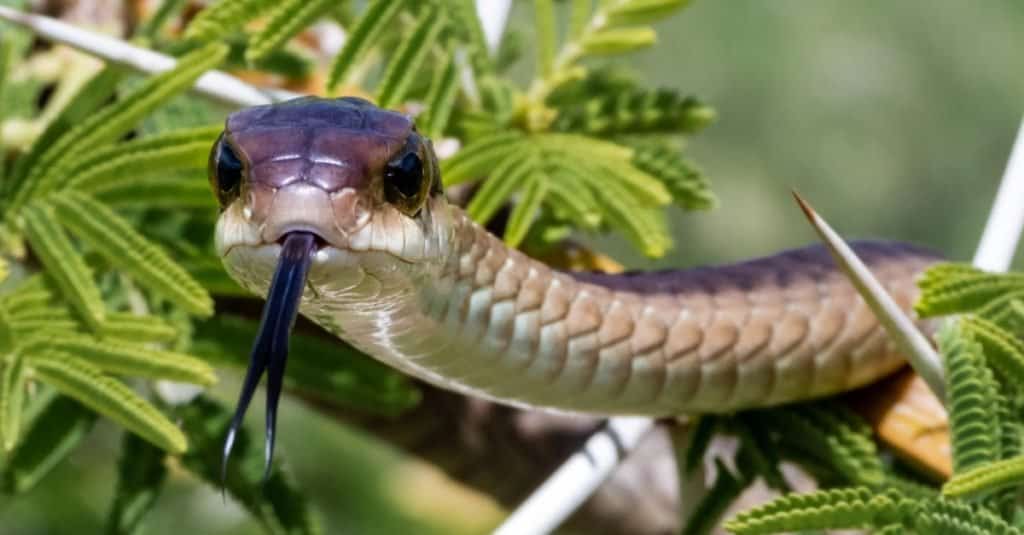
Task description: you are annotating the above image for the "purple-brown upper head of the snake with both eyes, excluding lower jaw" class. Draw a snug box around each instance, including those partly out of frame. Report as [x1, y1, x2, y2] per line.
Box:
[210, 97, 440, 249]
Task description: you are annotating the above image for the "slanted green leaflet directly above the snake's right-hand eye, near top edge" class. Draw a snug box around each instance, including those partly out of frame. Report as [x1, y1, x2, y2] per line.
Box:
[377, 6, 447, 108]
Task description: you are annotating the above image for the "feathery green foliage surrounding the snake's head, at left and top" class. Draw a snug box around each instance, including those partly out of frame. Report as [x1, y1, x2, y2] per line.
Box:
[0, 0, 720, 533]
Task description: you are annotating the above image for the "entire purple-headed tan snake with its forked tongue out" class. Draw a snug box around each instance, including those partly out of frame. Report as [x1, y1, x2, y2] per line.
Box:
[209, 97, 939, 469]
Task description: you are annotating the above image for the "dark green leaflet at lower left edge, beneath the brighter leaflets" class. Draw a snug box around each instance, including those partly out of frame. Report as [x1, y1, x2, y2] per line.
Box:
[2, 393, 96, 494]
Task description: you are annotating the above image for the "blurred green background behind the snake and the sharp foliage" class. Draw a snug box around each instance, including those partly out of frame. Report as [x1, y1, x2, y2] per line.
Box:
[0, 0, 1024, 535]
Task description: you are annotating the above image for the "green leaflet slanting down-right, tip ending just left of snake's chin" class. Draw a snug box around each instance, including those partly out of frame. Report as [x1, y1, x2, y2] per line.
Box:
[52, 192, 213, 316]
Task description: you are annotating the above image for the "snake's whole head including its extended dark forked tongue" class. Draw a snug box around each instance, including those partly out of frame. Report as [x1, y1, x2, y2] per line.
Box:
[209, 97, 444, 483]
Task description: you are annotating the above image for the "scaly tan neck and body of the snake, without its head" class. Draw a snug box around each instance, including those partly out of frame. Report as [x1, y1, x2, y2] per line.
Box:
[278, 201, 935, 416]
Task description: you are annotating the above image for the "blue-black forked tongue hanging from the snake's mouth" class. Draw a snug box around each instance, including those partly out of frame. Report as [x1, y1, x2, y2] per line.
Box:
[220, 232, 316, 486]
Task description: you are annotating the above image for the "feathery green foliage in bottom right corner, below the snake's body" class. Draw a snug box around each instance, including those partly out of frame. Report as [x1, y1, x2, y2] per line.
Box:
[726, 258, 1024, 535]
